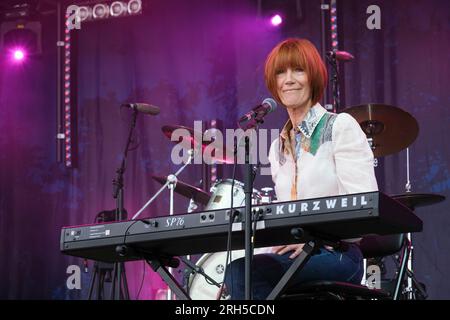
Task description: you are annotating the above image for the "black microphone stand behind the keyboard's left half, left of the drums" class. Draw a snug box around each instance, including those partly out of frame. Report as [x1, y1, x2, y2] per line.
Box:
[111, 109, 138, 300]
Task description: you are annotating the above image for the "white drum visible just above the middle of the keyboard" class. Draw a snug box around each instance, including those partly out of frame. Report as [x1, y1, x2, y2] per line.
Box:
[205, 179, 261, 210]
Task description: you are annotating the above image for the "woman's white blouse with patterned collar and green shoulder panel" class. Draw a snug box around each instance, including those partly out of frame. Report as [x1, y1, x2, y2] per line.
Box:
[269, 104, 378, 201]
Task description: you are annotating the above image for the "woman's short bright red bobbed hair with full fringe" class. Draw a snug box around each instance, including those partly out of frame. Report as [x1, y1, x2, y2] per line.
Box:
[264, 38, 328, 105]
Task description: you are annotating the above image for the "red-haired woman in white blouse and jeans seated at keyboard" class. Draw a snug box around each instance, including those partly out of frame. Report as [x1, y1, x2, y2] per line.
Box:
[225, 39, 378, 300]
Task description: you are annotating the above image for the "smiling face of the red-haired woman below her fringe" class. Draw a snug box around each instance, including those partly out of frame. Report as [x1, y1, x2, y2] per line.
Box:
[276, 68, 311, 108]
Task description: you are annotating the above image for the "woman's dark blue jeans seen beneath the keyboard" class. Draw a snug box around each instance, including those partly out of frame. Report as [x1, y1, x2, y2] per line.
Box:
[225, 244, 364, 300]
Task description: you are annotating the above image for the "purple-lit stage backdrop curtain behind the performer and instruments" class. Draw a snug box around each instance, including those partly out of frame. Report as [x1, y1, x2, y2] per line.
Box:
[0, 0, 450, 299]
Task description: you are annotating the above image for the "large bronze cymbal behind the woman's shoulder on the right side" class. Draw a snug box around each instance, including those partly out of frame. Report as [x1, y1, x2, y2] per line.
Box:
[343, 103, 419, 157]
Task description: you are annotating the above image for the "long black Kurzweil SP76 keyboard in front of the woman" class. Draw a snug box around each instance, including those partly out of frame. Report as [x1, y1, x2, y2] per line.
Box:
[60, 192, 422, 262]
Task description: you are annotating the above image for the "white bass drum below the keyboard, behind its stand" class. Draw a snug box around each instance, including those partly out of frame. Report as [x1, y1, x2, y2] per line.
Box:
[188, 248, 270, 300]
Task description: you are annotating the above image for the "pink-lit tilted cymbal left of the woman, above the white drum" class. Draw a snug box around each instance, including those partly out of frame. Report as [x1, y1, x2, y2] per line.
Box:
[161, 125, 234, 164]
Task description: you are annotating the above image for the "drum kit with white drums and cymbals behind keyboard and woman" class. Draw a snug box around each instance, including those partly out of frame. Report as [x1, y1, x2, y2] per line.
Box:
[146, 104, 445, 300]
